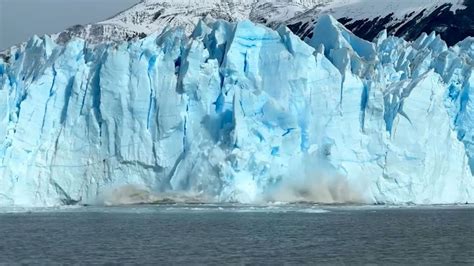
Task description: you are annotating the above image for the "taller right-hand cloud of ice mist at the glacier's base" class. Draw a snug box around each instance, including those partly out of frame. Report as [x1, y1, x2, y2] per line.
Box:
[266, 155, 369, 204]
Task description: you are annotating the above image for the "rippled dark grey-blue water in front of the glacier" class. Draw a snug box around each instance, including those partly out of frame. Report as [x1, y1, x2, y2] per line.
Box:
[0, 206, 474, 264]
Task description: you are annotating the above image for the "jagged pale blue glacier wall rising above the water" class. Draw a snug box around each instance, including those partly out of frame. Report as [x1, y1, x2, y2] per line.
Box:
[0, 16, 474, 206]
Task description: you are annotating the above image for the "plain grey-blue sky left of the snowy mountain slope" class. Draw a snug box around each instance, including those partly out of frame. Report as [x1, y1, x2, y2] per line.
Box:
[0, 0, 140, 50]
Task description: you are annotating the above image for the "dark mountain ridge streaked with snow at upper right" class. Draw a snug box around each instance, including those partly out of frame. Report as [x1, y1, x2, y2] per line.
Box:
[285, 0, 474, 45]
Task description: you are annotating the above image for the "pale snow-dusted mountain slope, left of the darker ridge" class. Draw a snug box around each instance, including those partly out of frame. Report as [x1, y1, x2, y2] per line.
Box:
[54, 0, 330, 42]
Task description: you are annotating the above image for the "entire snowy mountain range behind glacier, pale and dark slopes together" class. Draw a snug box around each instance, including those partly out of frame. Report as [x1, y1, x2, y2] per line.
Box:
[47, 0, 474, 45]
